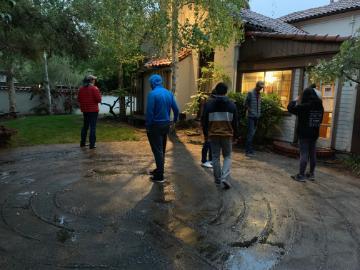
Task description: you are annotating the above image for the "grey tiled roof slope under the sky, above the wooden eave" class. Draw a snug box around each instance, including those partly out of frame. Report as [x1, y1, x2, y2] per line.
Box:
[240, 9, 306, 34]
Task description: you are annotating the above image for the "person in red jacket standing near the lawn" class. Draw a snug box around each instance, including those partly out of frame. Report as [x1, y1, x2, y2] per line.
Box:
[78, 75, 101, 149]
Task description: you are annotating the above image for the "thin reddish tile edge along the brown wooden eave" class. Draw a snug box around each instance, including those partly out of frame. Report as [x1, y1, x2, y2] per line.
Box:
[246, 32, 351, 43]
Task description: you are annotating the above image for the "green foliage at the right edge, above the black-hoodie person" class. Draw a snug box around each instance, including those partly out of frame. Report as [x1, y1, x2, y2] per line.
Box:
[310, 32, 360, 84]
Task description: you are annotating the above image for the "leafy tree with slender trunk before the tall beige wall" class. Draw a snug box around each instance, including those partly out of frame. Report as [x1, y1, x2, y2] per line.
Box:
[145, 0, 248, 92]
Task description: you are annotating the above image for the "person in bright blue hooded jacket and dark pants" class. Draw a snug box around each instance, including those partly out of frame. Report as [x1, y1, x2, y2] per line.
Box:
[146, 74, 179, 183]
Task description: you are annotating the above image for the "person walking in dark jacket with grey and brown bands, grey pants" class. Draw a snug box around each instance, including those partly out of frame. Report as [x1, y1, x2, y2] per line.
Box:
[202, 83, 239, 189]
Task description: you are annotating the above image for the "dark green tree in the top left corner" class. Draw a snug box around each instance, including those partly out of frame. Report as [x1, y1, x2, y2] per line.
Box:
[0, 0, 91, 113]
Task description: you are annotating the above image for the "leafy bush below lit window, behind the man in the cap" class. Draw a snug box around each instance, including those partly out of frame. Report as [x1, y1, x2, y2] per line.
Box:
[229, 93, 283, 142]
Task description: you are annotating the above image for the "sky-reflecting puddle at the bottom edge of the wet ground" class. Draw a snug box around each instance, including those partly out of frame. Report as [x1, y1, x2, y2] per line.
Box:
[225, 245, 283, 270]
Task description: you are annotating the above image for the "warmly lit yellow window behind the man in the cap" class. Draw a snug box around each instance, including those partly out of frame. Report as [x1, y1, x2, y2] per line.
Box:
[241, 70, 292, 108]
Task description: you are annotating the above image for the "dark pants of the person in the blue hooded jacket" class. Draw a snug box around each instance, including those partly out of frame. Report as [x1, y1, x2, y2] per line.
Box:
[147, 124, 170, 177]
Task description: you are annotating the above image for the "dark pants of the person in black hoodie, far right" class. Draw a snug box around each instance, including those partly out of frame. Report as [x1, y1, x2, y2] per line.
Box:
[299, 139, 316, 175]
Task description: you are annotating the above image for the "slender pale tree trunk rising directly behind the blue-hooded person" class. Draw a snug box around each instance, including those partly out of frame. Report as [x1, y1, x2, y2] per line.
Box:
[171, 0, 179, 93]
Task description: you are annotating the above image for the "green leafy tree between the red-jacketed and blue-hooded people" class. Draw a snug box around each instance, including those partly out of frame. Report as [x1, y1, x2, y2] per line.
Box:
[76, 0, 148, 116]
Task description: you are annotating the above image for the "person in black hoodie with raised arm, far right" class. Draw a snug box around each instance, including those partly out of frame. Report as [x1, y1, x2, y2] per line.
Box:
[288, 87, 324, 182]
